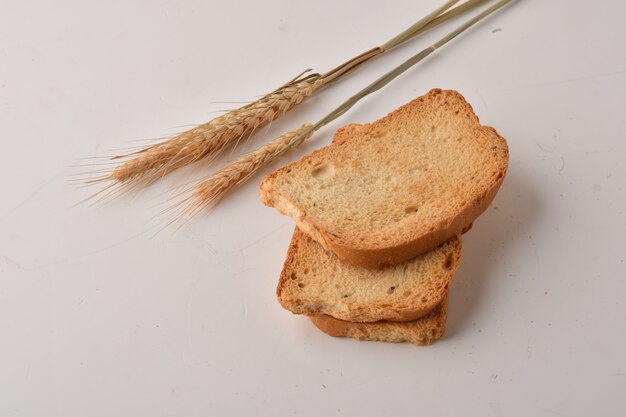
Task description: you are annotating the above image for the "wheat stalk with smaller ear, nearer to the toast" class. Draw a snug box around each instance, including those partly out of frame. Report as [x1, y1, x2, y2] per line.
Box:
[177, 0, 512, 219]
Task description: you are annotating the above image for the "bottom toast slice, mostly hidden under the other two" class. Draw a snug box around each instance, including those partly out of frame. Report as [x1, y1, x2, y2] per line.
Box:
[310, 296, 448, 345]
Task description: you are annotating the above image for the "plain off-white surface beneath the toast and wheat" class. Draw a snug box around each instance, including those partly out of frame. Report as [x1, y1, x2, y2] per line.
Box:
[0, 0, 626, 417]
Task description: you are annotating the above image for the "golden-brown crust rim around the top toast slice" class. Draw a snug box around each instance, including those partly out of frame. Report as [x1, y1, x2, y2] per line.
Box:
[260, 89, 508, 269]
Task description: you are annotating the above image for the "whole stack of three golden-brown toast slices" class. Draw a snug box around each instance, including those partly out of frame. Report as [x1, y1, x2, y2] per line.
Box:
[260, 89, 508, 344]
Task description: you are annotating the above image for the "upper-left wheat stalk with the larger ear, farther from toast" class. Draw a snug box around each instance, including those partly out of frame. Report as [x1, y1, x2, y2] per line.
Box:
[85, 0, 488, 197]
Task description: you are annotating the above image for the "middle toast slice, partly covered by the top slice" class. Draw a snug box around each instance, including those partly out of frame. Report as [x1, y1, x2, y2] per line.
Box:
[276, 228, 461, 322]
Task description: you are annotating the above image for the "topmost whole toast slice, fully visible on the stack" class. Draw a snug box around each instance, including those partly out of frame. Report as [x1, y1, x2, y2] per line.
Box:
[260, 90, 508, 269]
